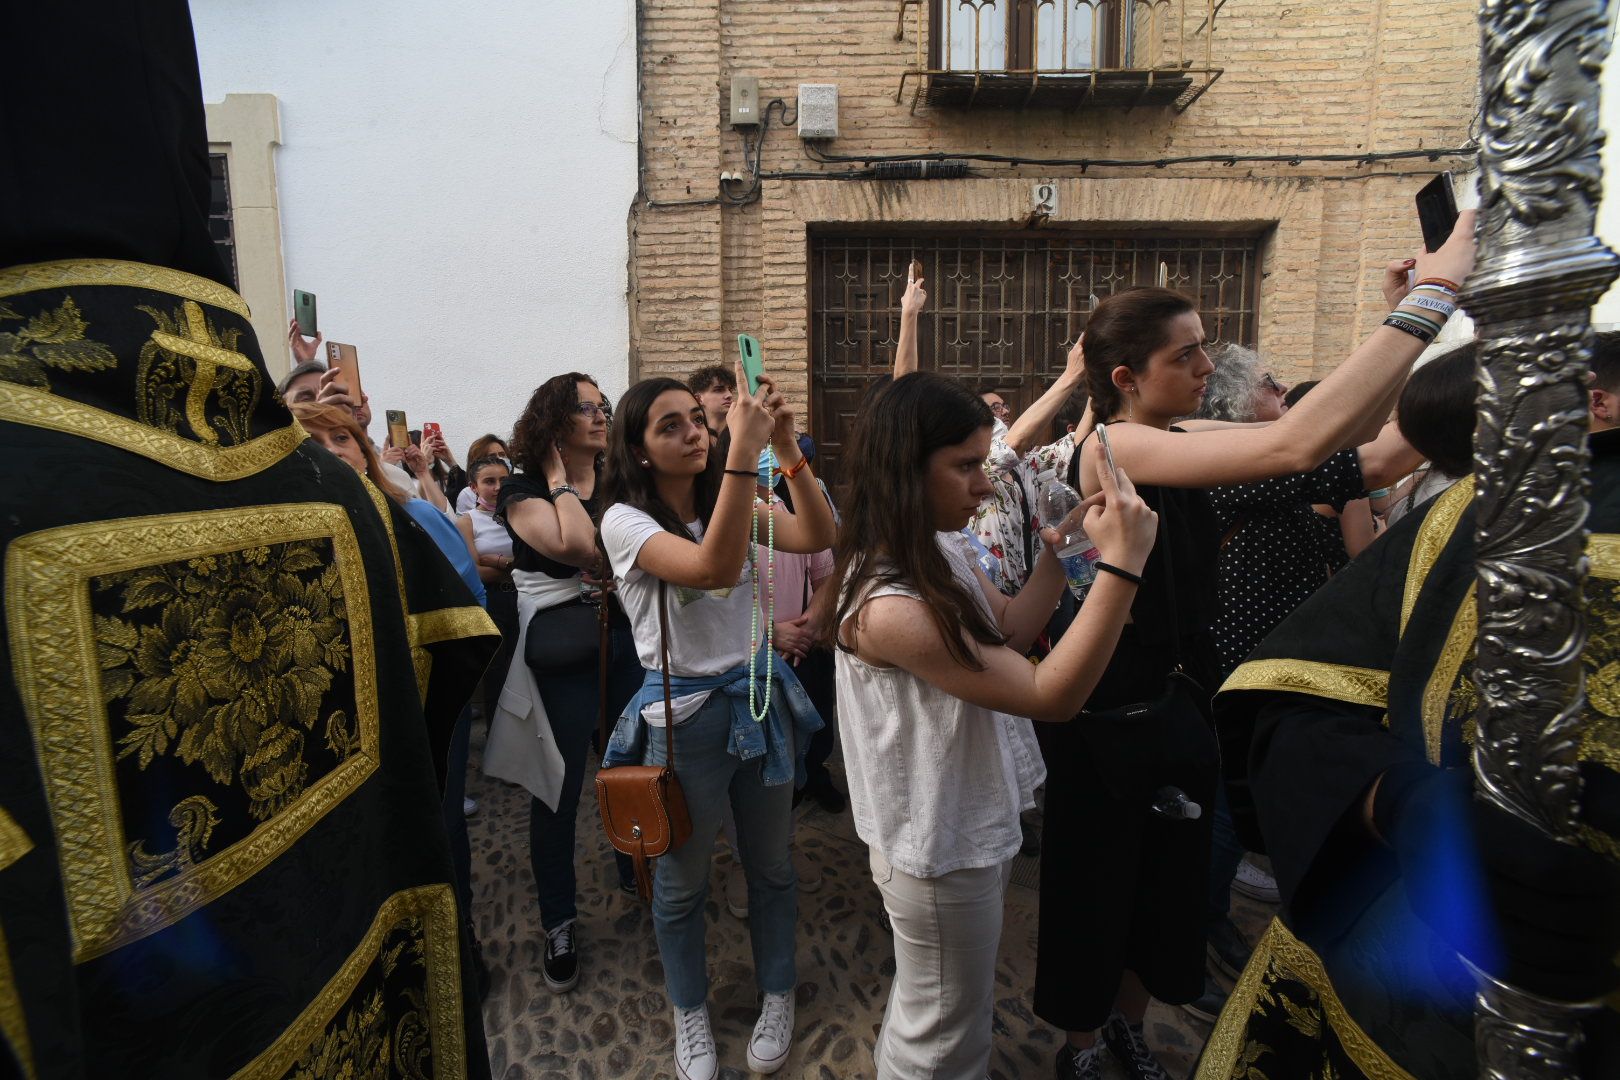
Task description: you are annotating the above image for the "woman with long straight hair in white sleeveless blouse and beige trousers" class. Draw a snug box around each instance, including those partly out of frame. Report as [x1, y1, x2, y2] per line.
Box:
[834, 372, 1157, 1080]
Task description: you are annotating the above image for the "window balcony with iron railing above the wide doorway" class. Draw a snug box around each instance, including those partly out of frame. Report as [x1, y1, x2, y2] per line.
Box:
[894, 0, 1226, 112]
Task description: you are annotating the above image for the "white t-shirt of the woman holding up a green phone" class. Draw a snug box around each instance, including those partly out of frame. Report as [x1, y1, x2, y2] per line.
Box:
[601, 502, 763, 724]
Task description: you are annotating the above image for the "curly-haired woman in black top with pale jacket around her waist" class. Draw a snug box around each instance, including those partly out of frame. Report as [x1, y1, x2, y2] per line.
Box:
[484, 371, 642, 993]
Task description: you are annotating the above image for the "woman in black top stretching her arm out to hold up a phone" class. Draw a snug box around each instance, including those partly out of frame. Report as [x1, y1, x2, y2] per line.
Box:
[1035, 214, 1473, 1080]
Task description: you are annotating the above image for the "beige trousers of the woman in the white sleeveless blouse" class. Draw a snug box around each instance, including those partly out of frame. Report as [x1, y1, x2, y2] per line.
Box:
[870, 848, 1013, 1080]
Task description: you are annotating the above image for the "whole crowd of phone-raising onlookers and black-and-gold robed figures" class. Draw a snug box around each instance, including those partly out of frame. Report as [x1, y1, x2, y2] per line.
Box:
[0, 3, 1620, 1080]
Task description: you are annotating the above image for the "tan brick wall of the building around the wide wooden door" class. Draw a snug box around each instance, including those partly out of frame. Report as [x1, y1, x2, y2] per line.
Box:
[630, 0, 1479, 423]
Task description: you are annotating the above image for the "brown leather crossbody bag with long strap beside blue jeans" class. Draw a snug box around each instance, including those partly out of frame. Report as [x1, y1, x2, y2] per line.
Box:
[596, 581, 692, 900]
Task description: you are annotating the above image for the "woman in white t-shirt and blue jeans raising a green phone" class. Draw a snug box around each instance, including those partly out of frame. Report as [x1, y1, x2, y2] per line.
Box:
[601, 364, 834, 1080]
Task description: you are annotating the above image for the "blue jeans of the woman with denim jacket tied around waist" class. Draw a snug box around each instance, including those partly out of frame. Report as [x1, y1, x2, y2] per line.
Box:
[646, 693, 799, 1009]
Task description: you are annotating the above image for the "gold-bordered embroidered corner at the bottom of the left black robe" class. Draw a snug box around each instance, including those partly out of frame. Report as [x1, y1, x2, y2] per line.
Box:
[233, 884, 467, 1080]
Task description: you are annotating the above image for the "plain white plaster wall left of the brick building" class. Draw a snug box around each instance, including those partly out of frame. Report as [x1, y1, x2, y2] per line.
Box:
[191, 0, 637, 458]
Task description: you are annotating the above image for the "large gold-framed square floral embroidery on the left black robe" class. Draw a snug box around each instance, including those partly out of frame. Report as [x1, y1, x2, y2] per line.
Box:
[5, 504, 379, 962]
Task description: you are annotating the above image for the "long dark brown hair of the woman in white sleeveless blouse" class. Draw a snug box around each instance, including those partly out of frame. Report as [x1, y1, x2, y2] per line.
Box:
[833, 371, 1006, 670]
